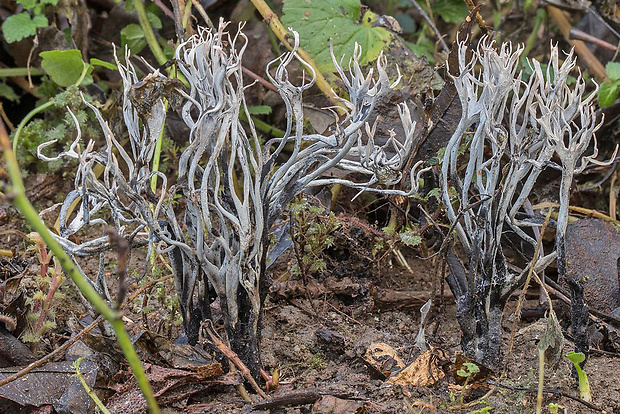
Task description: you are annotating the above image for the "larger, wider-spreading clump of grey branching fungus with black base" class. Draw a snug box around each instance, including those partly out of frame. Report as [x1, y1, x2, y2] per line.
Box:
[40, 23, 426, 377]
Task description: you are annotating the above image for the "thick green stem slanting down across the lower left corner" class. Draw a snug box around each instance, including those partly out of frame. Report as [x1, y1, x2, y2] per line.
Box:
[0, 120, 159, 414]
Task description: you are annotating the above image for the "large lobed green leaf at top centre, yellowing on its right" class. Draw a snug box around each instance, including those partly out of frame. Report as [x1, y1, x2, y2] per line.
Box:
[281, 0, 393, 71]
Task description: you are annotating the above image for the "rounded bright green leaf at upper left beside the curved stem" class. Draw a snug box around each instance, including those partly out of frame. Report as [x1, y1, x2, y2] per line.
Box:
[40, 49, 93, 87]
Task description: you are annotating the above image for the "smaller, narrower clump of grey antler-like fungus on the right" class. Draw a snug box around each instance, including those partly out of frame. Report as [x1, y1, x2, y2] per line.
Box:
[441, 38, 612, 367]
